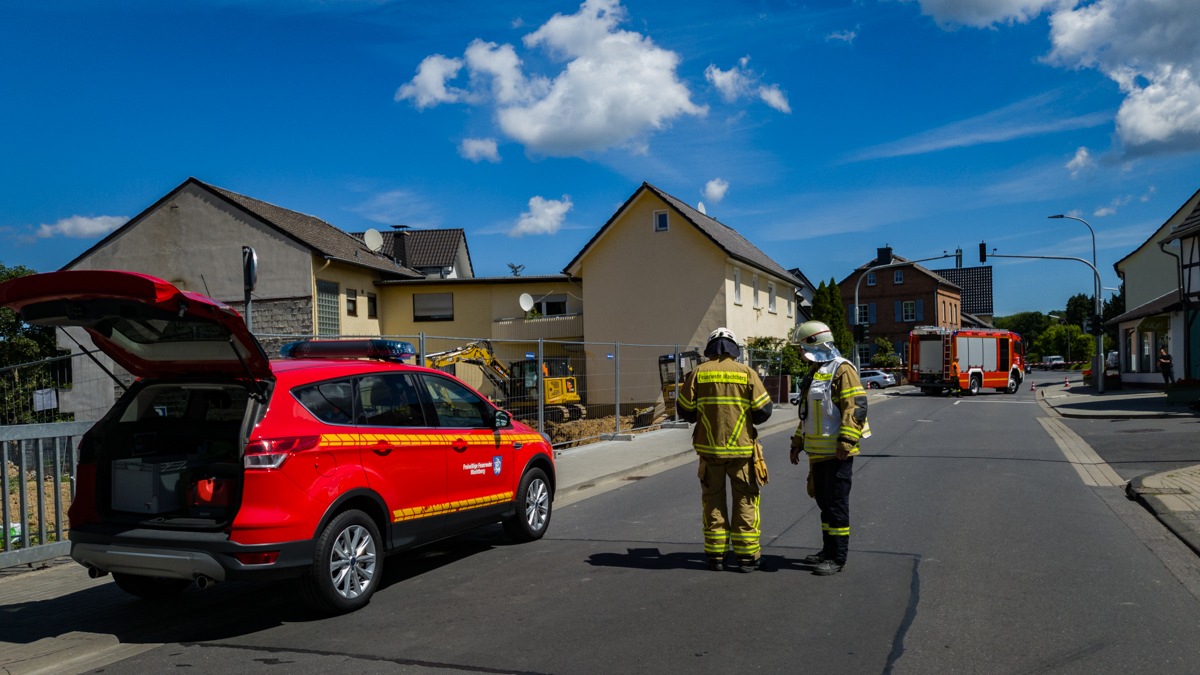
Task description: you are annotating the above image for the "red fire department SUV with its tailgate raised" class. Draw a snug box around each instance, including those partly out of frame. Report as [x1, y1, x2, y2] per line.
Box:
[0, 271, 554, 613]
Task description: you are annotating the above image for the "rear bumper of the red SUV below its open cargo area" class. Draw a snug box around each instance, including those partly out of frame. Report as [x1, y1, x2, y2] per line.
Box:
[70, 530, 314, 581]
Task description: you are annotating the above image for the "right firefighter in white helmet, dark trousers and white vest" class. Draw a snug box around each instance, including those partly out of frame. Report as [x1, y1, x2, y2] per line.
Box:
[791, 321, 871, 569]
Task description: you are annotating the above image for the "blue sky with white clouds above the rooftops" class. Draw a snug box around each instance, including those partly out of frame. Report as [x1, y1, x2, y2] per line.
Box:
[0, 0, 1200, 315]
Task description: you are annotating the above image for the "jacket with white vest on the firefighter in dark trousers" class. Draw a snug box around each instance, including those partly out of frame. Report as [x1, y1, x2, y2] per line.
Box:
[797, 357, 871, 461]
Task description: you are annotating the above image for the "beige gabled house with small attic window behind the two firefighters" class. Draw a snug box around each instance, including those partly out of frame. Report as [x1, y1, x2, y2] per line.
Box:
[563, 183, 802, 402]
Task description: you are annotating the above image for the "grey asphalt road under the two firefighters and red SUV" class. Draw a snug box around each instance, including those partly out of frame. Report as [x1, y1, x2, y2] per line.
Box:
[25, 381, 1200, 674]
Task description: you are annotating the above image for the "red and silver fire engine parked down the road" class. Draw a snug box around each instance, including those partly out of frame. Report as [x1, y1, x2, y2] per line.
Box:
[908, 325, 1025, 395]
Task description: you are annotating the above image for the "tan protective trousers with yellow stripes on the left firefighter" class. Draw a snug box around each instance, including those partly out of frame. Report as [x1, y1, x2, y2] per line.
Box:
[698, 455, 760, 562]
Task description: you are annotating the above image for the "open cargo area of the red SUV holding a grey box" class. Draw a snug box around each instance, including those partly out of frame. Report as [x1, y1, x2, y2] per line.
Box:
[85, 382, 253, 528]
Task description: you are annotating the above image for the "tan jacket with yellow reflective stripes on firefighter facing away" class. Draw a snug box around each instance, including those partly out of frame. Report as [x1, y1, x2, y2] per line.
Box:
[677, 357, 770, 458]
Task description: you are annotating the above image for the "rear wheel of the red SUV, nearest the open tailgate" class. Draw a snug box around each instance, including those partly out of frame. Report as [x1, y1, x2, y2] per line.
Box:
[300, 509, 383, 614]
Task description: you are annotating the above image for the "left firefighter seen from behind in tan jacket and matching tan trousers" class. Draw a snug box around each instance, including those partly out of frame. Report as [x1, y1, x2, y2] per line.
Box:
[678, 327, 772, 572]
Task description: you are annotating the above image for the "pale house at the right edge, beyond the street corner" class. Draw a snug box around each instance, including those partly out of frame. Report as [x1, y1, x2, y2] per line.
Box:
[1109, 186, 1200, 387]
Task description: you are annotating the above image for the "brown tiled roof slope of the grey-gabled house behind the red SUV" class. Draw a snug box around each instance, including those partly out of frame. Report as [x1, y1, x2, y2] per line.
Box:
[204, 178, 424, 277]
